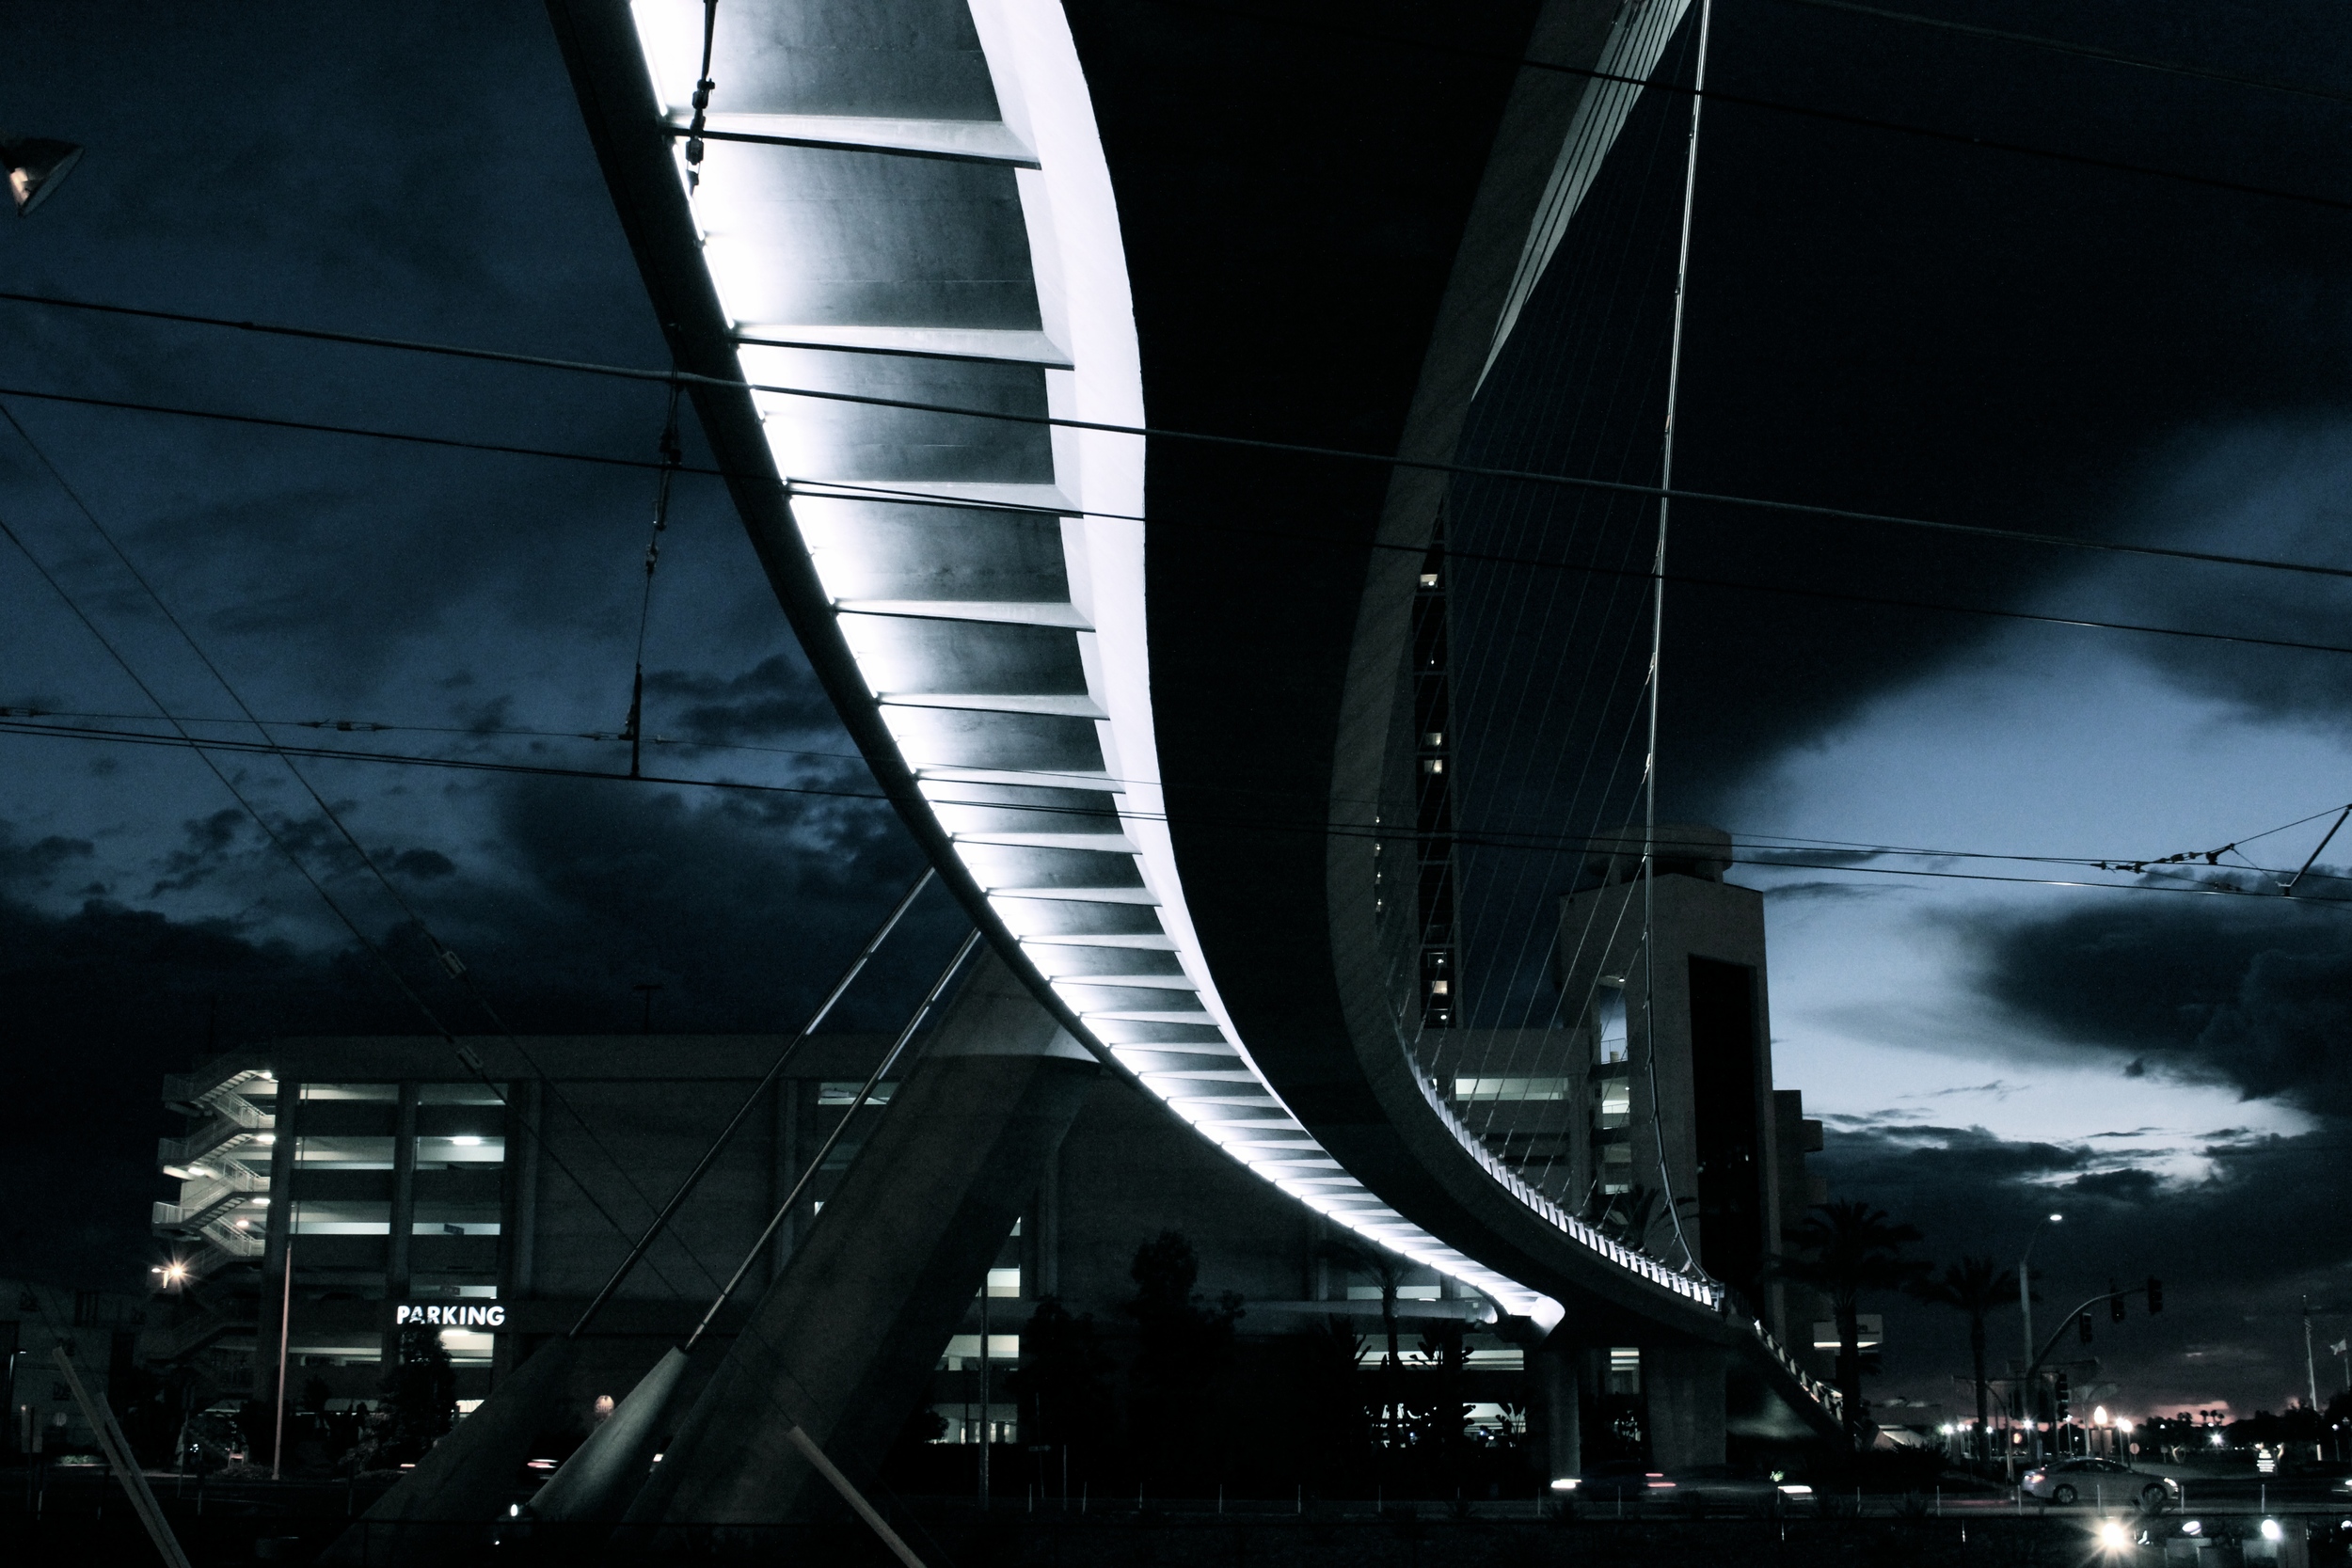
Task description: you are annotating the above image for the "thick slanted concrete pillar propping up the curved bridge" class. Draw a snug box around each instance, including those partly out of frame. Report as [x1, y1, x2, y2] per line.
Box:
[628, 955, 1101, 1547]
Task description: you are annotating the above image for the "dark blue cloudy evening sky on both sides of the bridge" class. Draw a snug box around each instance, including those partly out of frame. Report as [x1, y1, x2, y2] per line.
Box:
[0, 0, 2352, 1408]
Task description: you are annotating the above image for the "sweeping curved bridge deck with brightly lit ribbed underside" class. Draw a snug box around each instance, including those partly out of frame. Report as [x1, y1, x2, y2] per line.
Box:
[553, 0, 1835, 1419]
